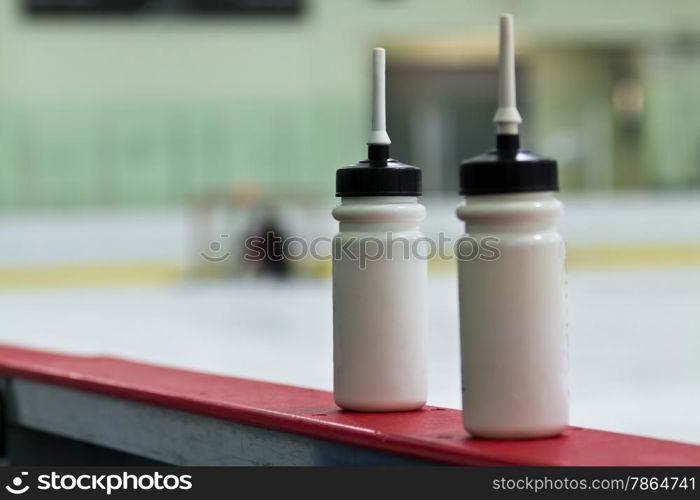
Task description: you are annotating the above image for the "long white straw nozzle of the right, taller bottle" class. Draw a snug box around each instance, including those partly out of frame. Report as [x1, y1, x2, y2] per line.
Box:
[493, 14, 523, 135]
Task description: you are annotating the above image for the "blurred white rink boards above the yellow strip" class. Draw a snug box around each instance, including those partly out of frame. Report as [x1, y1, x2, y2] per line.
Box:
[0, 193, 700, 267]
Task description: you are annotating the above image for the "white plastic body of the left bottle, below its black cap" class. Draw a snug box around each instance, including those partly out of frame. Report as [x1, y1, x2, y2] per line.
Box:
[333, 196, 428, 412]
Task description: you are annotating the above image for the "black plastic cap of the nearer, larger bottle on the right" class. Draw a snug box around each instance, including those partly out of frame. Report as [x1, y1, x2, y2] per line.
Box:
[459, 134, 559, 195]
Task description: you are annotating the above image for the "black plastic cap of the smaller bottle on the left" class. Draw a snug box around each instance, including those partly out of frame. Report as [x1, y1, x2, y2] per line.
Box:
[335, 145, 422, 197]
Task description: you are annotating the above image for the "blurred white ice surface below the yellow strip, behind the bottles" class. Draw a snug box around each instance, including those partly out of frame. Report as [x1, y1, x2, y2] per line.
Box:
[0, 269, 700, 443]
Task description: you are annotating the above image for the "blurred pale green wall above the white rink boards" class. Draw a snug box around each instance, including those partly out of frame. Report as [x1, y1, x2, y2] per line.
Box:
[0, 0, 700, 209]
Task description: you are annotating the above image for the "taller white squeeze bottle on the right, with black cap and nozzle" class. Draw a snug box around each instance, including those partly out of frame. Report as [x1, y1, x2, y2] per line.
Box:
[457, 14, 569, 439]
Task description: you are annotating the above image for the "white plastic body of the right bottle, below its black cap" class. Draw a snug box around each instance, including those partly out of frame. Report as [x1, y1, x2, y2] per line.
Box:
[457, 192, 569, 439]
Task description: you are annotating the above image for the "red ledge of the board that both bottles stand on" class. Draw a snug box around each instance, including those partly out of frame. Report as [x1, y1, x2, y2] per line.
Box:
[0, 346, 700, 466]
